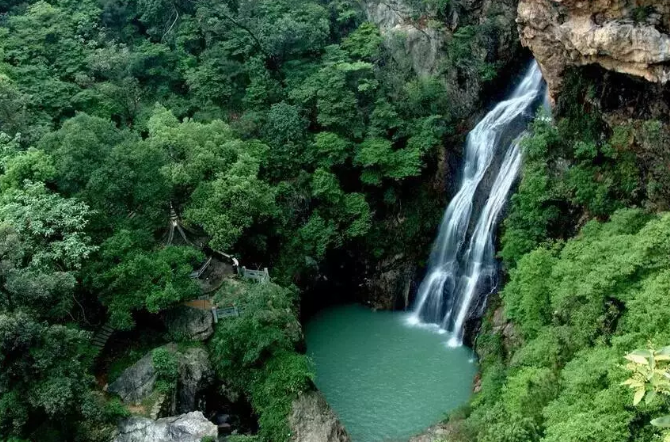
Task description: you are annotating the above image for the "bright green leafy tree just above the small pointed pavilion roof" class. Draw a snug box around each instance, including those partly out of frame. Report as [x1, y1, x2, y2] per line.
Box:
[147, 108, 276, 249]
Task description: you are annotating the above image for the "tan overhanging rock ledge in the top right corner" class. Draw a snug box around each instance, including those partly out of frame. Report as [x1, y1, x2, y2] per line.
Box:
[517, 0, 670, 97]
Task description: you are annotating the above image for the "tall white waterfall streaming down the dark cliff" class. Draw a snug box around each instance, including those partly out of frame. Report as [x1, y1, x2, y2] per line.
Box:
[410, 62, 545, 346]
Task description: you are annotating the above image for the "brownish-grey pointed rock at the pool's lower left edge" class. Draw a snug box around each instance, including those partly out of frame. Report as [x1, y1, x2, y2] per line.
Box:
[289, 391, 351, 442]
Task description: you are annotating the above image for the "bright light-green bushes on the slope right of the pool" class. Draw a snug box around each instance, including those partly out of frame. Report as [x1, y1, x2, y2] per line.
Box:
[452, 209, 670, 442]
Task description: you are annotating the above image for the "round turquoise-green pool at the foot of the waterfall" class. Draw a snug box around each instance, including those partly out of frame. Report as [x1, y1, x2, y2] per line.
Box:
[306, 305, 476, 442]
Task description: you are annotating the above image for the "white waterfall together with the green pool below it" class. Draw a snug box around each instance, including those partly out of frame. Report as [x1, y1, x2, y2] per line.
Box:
[306, 63, 544, 442]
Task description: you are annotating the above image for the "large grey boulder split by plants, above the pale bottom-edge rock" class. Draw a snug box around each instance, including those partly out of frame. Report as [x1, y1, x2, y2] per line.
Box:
[107, 344, 214, 413]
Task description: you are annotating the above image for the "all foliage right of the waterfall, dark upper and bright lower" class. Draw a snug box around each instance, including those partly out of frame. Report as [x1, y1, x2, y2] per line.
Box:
[450, 72, 670, 442]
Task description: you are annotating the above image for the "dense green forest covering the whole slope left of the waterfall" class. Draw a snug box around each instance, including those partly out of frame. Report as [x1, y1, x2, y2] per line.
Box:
[0, 0, 468, 441]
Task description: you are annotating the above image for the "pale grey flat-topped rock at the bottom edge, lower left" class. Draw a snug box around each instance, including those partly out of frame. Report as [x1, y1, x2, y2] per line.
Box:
[114, 411, 217, 442]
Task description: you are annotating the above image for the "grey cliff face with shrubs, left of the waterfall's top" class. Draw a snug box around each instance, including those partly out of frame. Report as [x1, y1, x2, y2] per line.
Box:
[362, 0, 520, 118]
